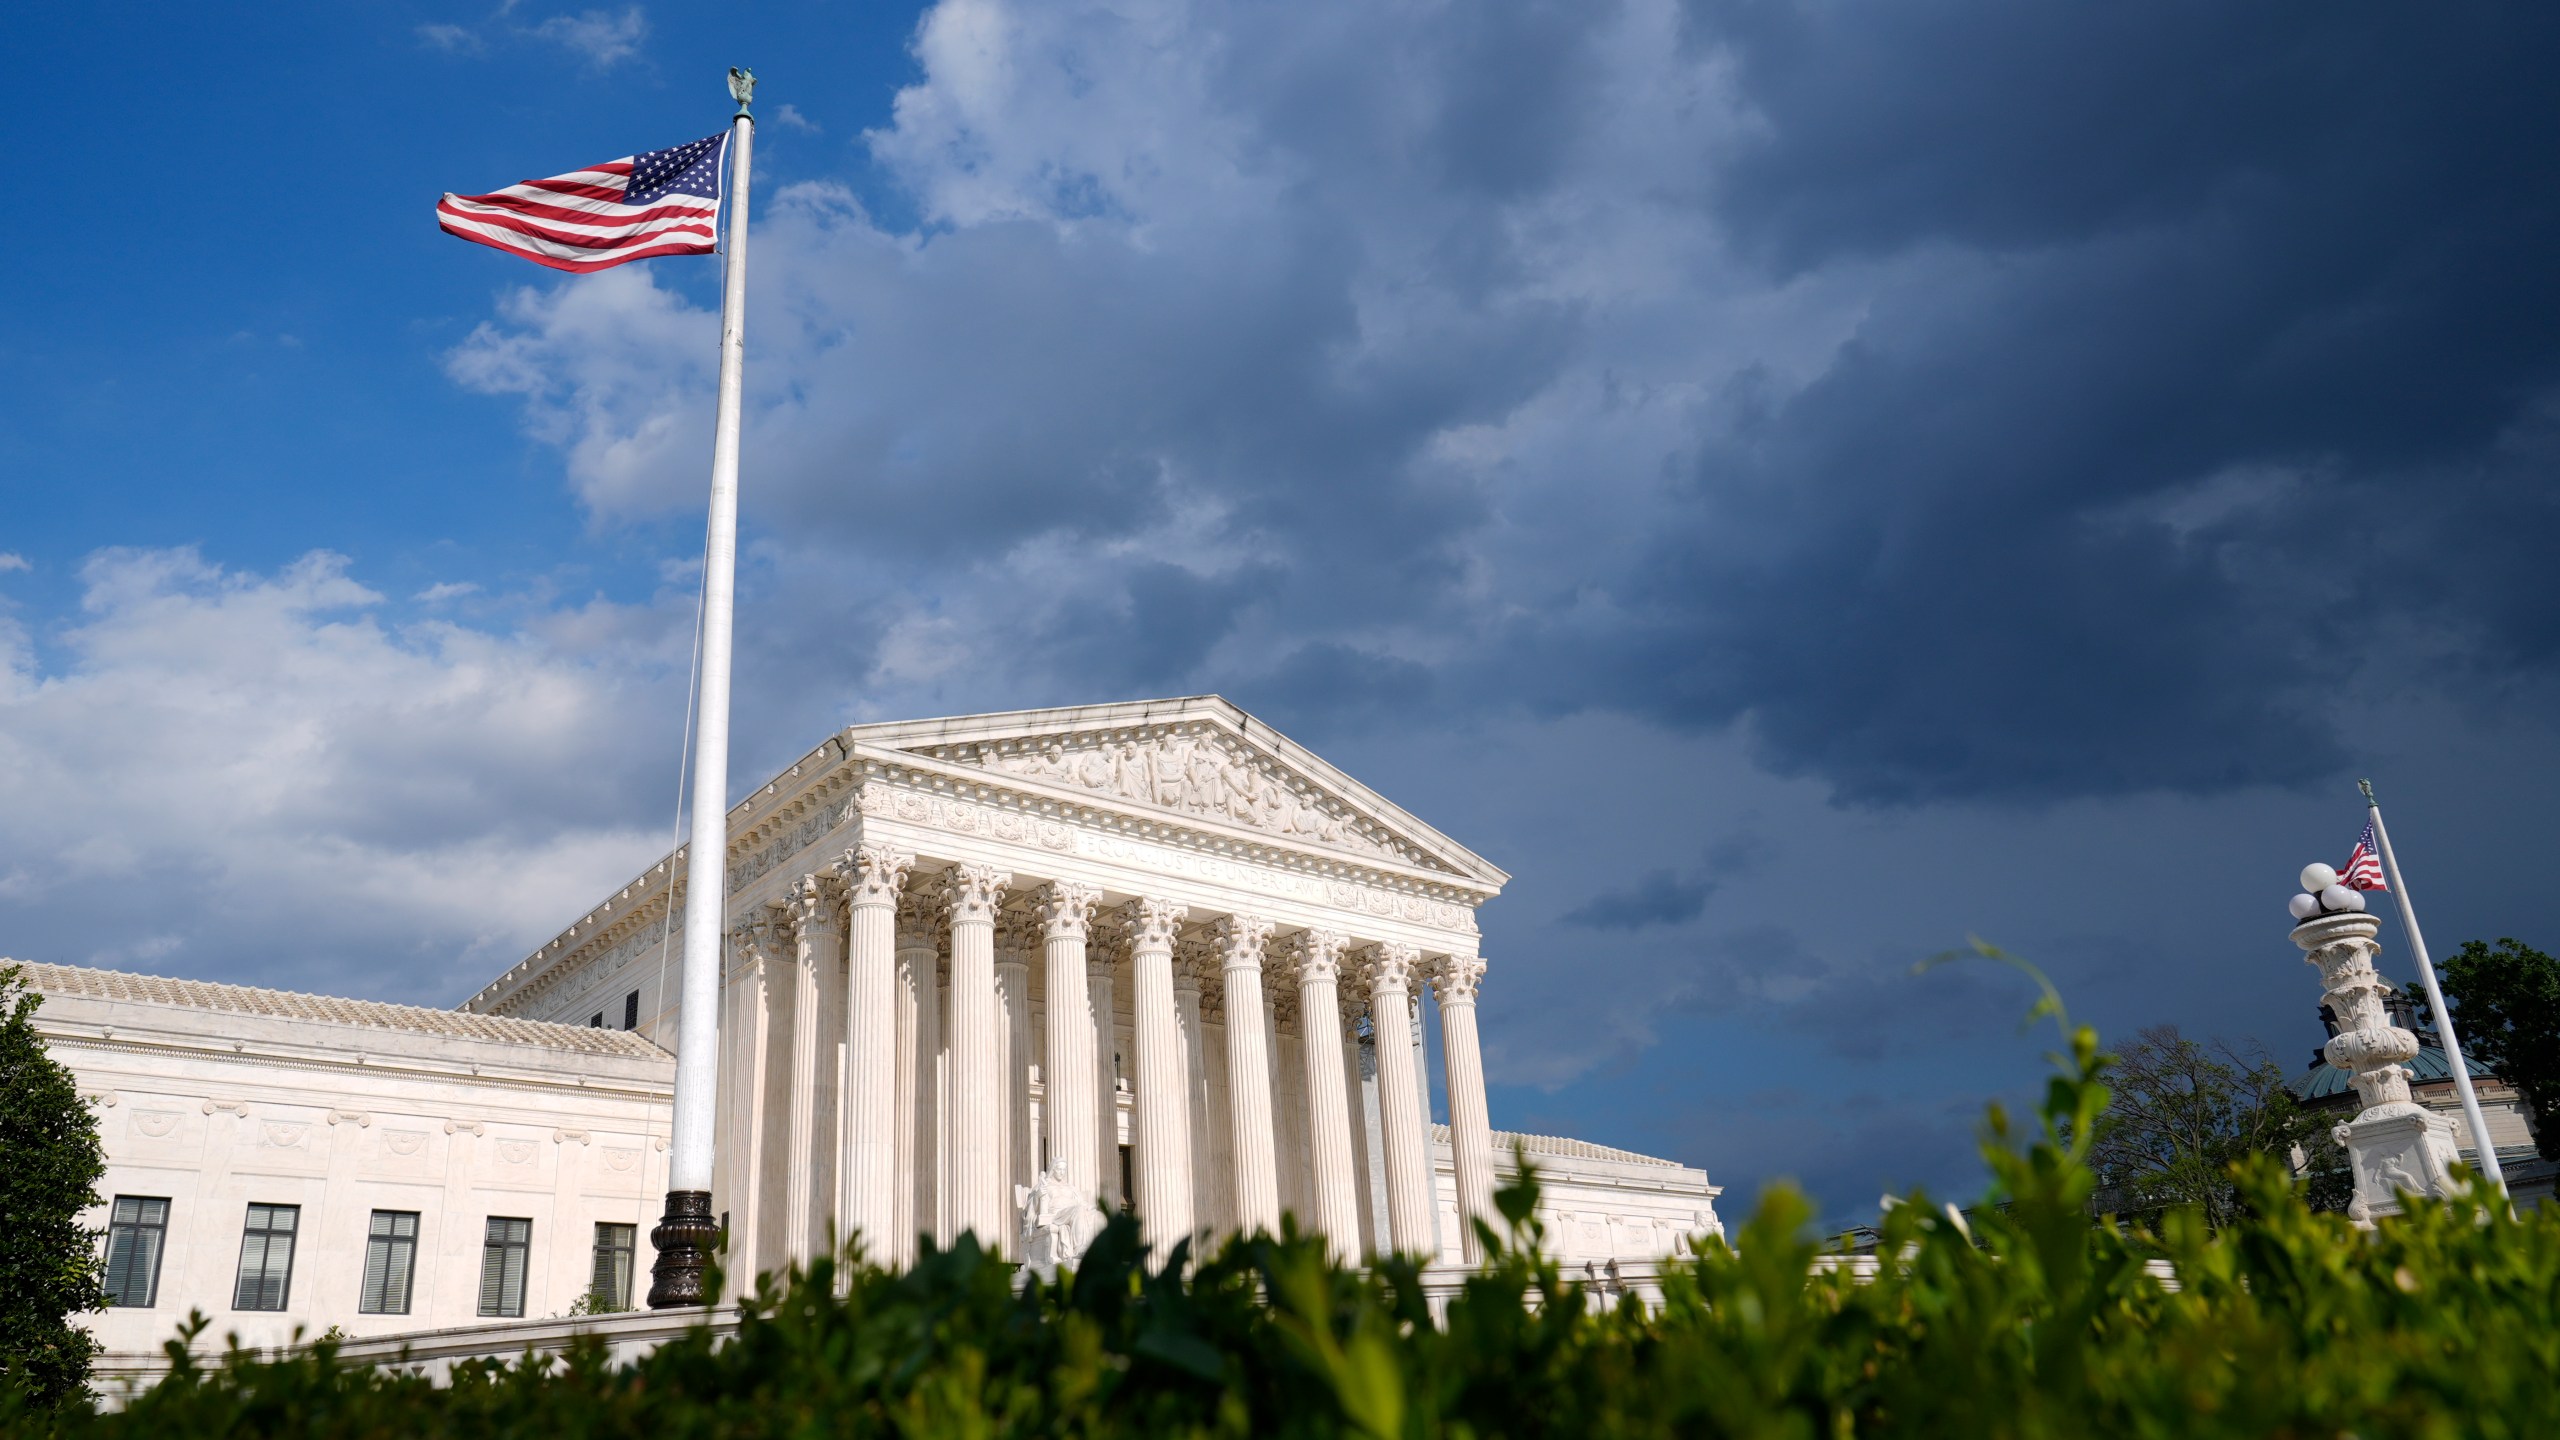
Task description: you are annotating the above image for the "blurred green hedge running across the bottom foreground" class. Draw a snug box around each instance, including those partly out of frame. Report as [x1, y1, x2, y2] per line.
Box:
[15, 983, 2560, 1440]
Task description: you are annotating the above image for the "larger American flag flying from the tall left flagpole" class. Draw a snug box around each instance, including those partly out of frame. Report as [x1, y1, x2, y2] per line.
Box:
[435, 133, 730, 272]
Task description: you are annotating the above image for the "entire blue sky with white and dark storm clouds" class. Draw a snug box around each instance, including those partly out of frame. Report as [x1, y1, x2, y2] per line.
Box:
[0, 0, 2560, 1217]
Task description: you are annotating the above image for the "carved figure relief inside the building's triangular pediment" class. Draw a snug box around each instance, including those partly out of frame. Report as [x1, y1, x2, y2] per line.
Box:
[932, 735, 1446, 869]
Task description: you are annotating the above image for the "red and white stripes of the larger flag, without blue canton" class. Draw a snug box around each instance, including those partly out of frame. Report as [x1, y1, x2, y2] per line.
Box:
[435, 156, 719, 274]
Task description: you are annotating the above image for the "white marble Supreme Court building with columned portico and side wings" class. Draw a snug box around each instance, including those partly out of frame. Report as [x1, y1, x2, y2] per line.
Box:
[28, 697, 1718, 1353]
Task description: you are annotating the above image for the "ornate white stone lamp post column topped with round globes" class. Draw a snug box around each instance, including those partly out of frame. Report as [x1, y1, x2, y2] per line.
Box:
[2294, 866, 2458, 1225]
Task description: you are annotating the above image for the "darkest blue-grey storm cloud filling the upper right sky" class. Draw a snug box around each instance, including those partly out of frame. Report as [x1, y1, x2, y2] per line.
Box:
[1523, 5, 2560, 802]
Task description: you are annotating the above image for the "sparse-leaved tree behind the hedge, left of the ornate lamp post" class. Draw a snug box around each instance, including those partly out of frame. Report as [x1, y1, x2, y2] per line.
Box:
[2089, 1025, 2335, 1230]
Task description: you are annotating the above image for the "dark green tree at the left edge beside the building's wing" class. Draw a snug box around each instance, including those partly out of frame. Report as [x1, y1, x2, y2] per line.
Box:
[0, 966, 108, 1407]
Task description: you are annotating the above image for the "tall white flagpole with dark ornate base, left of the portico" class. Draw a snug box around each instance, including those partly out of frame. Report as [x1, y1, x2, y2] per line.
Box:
[648, 69, 755, 1309]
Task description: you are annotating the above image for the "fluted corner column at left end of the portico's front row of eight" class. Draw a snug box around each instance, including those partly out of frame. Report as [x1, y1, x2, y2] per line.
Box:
[835, 846, 916, 1266]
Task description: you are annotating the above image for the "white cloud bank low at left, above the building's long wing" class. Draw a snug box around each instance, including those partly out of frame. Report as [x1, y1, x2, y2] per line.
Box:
[0, 551, 686, 1002]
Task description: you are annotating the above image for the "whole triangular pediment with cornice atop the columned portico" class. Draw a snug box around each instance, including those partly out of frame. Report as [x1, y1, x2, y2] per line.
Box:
[845, 694, 1510, 887]
